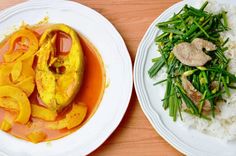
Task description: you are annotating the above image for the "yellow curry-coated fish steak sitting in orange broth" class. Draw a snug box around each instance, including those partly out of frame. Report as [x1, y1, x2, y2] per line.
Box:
[36, 24, 84, 112]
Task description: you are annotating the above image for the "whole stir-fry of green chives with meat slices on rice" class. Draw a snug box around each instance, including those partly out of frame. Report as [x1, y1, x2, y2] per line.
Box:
[148, 2, 236, 121]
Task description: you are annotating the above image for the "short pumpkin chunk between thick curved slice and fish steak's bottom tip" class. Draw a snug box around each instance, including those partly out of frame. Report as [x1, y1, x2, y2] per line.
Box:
[31, 104, 57, 121]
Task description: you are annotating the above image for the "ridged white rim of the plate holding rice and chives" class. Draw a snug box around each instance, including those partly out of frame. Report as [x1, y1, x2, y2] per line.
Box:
[134, 0, 203, 155]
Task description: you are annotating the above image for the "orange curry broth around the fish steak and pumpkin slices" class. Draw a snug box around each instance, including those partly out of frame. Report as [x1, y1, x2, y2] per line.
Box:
[0, 25, 105, 141]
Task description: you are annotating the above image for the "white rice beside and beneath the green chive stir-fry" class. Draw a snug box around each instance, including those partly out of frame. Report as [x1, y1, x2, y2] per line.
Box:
[183, 0, 236, 141]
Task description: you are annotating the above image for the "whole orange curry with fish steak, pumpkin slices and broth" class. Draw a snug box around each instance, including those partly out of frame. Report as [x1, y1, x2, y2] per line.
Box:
[0, 24, 105, 143]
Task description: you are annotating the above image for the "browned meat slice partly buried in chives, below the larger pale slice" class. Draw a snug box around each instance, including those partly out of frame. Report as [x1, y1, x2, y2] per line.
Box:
[181, 75, 211, 112]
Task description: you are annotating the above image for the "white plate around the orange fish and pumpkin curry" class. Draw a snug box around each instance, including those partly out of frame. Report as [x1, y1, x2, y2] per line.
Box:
[0, 0, 132, 156]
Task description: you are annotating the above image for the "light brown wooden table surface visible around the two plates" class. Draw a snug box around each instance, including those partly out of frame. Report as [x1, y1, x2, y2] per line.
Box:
[0, 0, 182, 156]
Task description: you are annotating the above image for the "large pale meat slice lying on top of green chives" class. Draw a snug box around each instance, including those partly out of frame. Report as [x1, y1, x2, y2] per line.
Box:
[173, 38, 216, 67]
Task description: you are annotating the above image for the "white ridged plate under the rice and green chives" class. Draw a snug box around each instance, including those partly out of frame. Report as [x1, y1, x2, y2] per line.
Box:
[134, 0, 236, 156]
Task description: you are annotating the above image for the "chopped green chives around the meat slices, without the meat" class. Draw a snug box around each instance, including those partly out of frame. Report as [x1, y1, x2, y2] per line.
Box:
[148, 2, 236, 121]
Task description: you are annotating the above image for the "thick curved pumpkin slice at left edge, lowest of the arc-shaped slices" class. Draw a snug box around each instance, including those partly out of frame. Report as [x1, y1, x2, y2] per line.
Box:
[0, 86, 31, 124]
